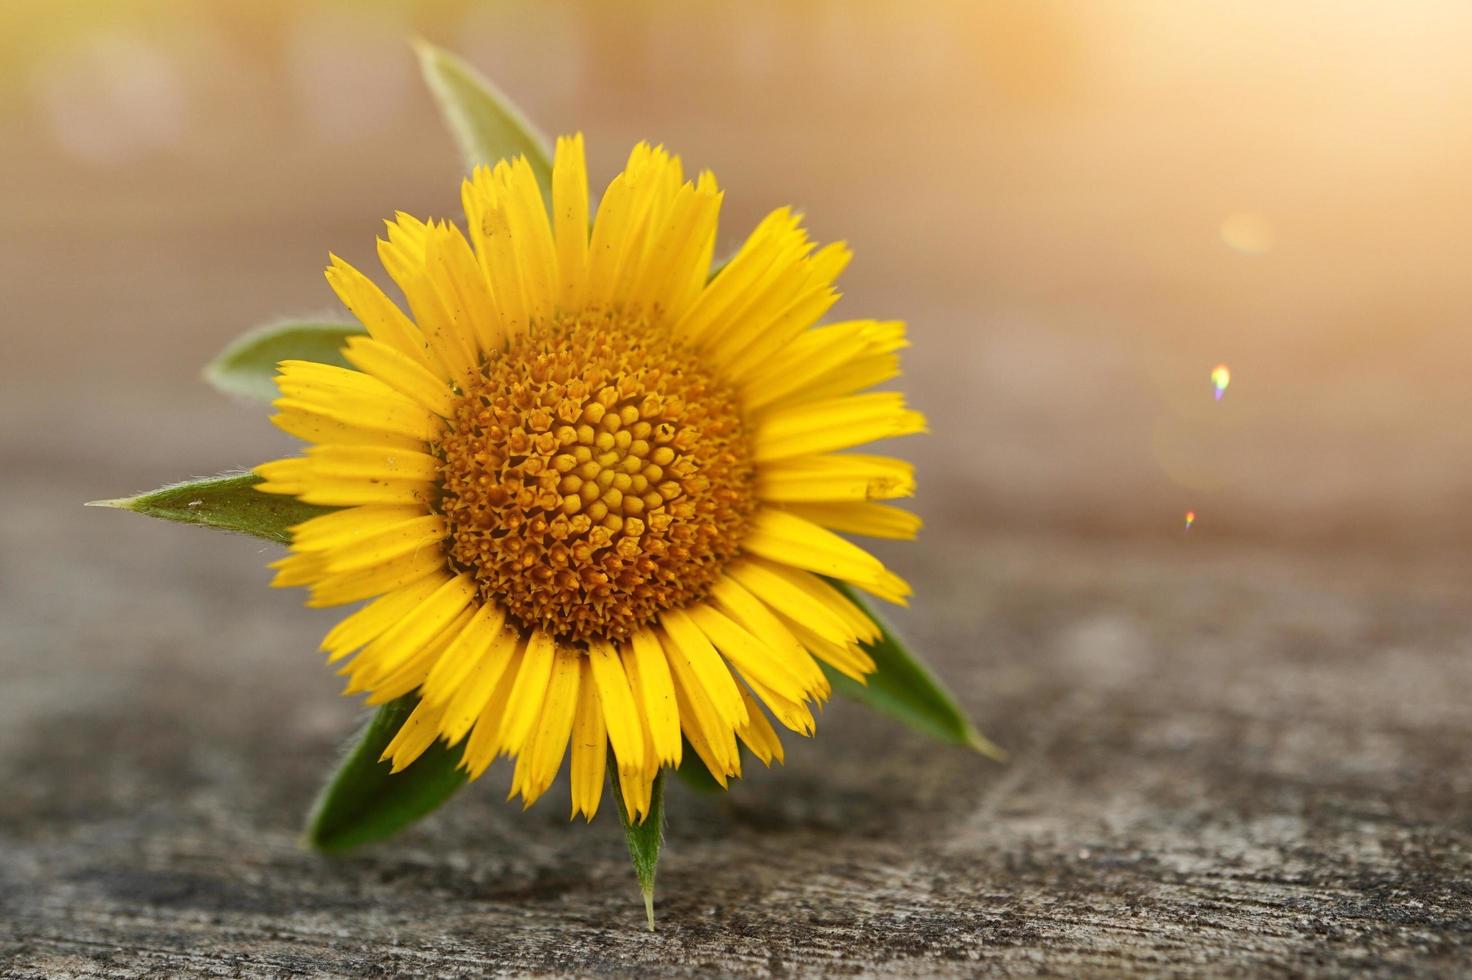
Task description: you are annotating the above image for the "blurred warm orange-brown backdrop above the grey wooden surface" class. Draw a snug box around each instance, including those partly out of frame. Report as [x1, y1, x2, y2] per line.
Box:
[0, 0, 1472, 547]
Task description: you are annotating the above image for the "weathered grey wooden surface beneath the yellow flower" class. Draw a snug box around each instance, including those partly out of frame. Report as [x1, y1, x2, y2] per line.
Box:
[0, 473, 1472, 977]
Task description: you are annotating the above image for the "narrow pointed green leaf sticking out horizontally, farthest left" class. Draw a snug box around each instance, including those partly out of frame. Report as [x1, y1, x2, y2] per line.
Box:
[87, 472, 336, 543]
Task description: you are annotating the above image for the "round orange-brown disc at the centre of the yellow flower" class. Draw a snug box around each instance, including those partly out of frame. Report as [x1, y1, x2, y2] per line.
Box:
[434, 310, 757, 640]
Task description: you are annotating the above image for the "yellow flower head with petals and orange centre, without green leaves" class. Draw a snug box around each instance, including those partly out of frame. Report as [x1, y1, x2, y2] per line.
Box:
[256, 135, 924, 818]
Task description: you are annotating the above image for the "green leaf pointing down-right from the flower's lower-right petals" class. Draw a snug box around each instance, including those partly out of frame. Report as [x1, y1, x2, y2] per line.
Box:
[824, 578, 1007, 761]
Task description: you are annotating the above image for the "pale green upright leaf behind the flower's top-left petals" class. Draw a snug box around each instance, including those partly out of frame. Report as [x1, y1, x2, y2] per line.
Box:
[414, 41, 552, 206]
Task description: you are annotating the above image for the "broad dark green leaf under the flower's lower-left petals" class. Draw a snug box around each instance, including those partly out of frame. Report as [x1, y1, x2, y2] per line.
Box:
[306, 695, 465, 852]
